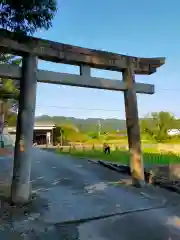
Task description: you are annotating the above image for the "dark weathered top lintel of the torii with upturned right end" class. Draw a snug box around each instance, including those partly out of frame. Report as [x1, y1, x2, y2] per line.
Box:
[0, 29, 165, 75]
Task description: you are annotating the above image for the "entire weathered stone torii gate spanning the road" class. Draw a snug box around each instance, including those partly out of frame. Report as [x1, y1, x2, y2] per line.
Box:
[0, 30, 165, 203]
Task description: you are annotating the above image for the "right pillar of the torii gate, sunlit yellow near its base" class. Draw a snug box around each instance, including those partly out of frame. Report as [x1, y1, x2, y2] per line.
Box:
[123, 64, 145, 187]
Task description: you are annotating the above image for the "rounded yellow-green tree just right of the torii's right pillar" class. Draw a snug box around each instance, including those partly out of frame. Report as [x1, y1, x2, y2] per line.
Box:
[140, 112, 176, 142]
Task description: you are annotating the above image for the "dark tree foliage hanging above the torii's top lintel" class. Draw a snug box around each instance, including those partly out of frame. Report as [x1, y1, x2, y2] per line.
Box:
[0, 0, 57, 35]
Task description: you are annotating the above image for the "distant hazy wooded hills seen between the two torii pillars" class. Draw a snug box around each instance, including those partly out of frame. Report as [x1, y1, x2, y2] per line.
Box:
[36, 115, 126, 132]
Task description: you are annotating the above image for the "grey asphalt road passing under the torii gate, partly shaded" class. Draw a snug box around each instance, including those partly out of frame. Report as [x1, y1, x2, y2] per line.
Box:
[0, 148, 180, 240]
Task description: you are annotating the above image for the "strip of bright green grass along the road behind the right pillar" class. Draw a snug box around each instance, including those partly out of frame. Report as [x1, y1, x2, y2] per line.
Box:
[57, 149, 180, 164]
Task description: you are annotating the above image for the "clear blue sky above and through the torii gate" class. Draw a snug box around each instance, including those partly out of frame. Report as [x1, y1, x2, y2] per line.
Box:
[33, 0, 180, 119]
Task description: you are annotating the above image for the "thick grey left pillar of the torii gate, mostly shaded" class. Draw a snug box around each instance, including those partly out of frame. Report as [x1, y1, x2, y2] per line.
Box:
[11, 54, 38, 204]
